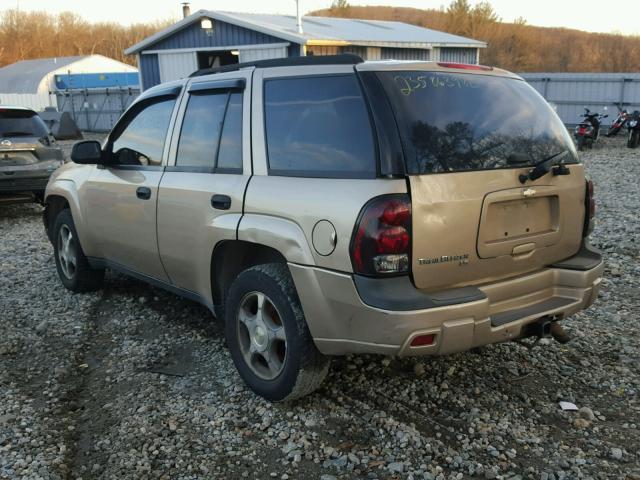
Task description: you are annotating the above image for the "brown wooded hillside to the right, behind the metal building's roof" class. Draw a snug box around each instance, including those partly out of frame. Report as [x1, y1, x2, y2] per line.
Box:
[322, 0, 640, 72]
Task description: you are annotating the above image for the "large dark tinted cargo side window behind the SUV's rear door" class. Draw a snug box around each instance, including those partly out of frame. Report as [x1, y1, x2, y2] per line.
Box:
[264, 75, 376, 178]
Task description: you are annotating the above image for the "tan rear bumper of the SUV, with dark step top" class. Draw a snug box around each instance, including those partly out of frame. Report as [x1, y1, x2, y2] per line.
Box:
[289, 244, 604, 356]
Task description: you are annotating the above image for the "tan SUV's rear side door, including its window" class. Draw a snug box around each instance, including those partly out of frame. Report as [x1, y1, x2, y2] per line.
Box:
[158, 70, 251, 299]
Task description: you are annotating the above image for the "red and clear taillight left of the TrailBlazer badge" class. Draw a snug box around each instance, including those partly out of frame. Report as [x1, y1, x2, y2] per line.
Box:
[350, 194, 411, 275]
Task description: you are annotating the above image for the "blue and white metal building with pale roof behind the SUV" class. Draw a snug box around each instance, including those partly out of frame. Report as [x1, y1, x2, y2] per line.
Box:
[125, 10, 487, 89]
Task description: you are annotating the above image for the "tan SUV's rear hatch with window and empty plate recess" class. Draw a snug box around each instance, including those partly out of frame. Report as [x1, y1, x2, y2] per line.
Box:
[378, 69, 585, 290]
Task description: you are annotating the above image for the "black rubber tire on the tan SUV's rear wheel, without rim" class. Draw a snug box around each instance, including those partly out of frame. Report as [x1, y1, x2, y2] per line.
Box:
[225, 263, 330, 402]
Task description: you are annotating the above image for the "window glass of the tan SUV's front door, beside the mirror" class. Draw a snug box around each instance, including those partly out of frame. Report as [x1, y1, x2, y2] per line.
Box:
[111, 98, 176, 166]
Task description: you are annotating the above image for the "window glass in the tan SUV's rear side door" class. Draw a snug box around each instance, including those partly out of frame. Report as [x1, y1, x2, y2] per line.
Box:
[176, 91, 242, 172]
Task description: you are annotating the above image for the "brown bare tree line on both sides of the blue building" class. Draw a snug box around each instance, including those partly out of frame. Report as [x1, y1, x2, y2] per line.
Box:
[0, 0, 640, 72]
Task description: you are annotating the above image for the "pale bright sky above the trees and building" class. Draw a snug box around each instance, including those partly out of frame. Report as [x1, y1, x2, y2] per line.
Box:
[7, 0, 640, 35]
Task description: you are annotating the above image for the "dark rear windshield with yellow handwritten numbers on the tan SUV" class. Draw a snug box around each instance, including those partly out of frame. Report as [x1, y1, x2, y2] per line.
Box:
[378, 71, 578, 174]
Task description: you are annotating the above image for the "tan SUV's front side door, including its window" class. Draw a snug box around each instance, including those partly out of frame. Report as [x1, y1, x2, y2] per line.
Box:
[83, 87, 180, 281]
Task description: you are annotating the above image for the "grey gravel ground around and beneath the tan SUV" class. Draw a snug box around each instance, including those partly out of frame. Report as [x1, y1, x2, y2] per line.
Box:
[0, 132, 640, 480]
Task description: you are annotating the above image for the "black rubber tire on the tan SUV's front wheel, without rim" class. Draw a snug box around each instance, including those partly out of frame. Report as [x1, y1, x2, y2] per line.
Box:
[53, 208, 104, 292]
